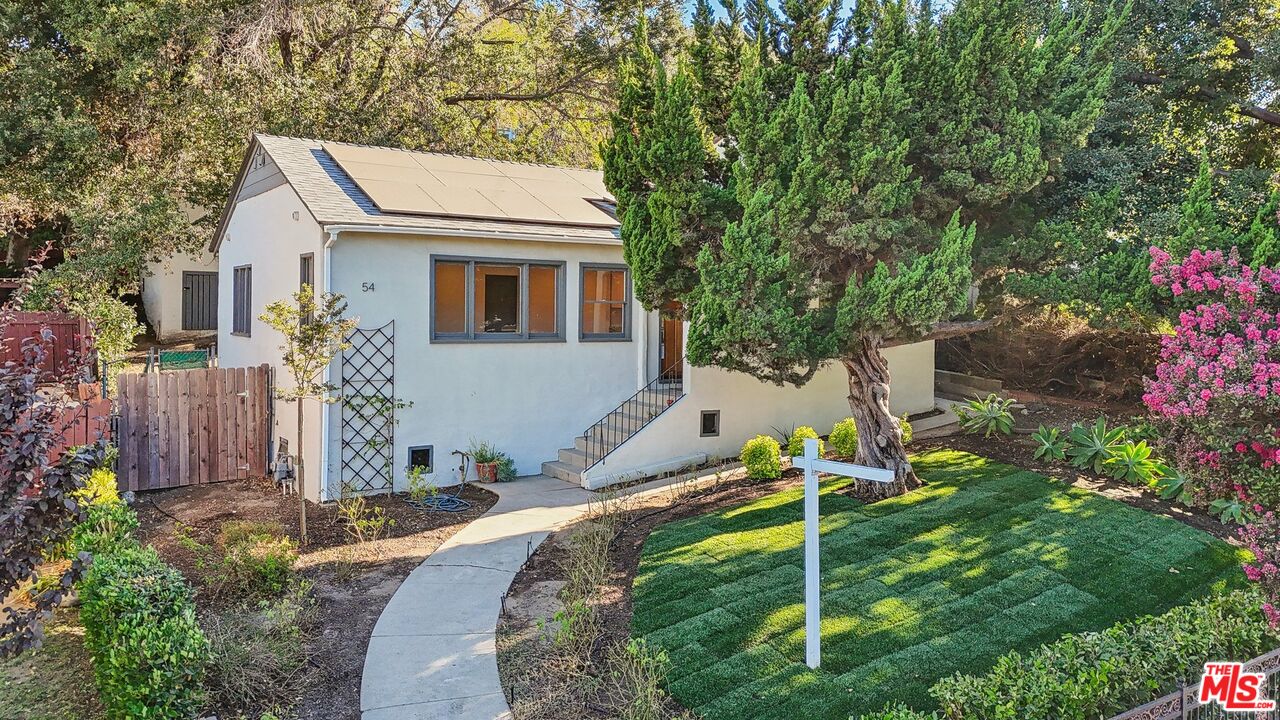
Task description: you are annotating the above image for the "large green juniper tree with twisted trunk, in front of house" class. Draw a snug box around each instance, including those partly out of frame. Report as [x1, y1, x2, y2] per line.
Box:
[603, 0, 1117, 492]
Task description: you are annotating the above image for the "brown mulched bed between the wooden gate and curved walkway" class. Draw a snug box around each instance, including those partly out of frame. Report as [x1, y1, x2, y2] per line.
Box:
[134, 479, 497, 720]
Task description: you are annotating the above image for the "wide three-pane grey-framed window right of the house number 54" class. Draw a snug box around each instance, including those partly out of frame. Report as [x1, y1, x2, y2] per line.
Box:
[431, 258, 564, 342]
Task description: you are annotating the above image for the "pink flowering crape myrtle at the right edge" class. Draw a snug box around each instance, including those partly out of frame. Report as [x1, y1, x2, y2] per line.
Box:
[1143, 247, 1280, 625]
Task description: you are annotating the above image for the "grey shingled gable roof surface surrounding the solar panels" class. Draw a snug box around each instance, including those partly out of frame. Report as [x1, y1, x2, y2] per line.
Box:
[210, 133, 621, 252]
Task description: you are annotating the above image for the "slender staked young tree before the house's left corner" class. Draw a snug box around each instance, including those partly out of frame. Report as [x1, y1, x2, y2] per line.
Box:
[259, 284, 360, 544]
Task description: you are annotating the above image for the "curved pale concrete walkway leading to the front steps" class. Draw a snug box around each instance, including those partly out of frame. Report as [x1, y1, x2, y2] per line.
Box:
[360, 470, 736, 720]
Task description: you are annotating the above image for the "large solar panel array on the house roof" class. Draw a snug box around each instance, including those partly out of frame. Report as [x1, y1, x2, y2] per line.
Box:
[324, 142, 618, 227]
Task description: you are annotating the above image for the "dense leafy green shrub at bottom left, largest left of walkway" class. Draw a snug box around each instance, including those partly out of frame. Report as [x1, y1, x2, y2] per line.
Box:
[81, 547, 209, 720]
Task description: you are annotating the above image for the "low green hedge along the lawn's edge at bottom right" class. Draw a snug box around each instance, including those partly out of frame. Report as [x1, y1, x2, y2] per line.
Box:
[929, 591, 1280, 720]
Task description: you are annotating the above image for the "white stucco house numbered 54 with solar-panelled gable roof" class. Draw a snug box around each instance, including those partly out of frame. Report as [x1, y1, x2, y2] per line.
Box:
[210, 135, 934, 500]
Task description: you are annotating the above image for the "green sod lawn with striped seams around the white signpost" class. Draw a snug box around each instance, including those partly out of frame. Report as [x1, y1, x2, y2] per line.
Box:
[632, 451, 1244, 720]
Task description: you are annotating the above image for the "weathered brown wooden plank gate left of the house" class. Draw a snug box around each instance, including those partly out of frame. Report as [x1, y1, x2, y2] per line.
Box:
[116, 365, 271, 491]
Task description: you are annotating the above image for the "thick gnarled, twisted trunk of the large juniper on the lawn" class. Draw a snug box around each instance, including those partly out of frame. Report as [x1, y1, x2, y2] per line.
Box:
[841, 336, 922, 497]
